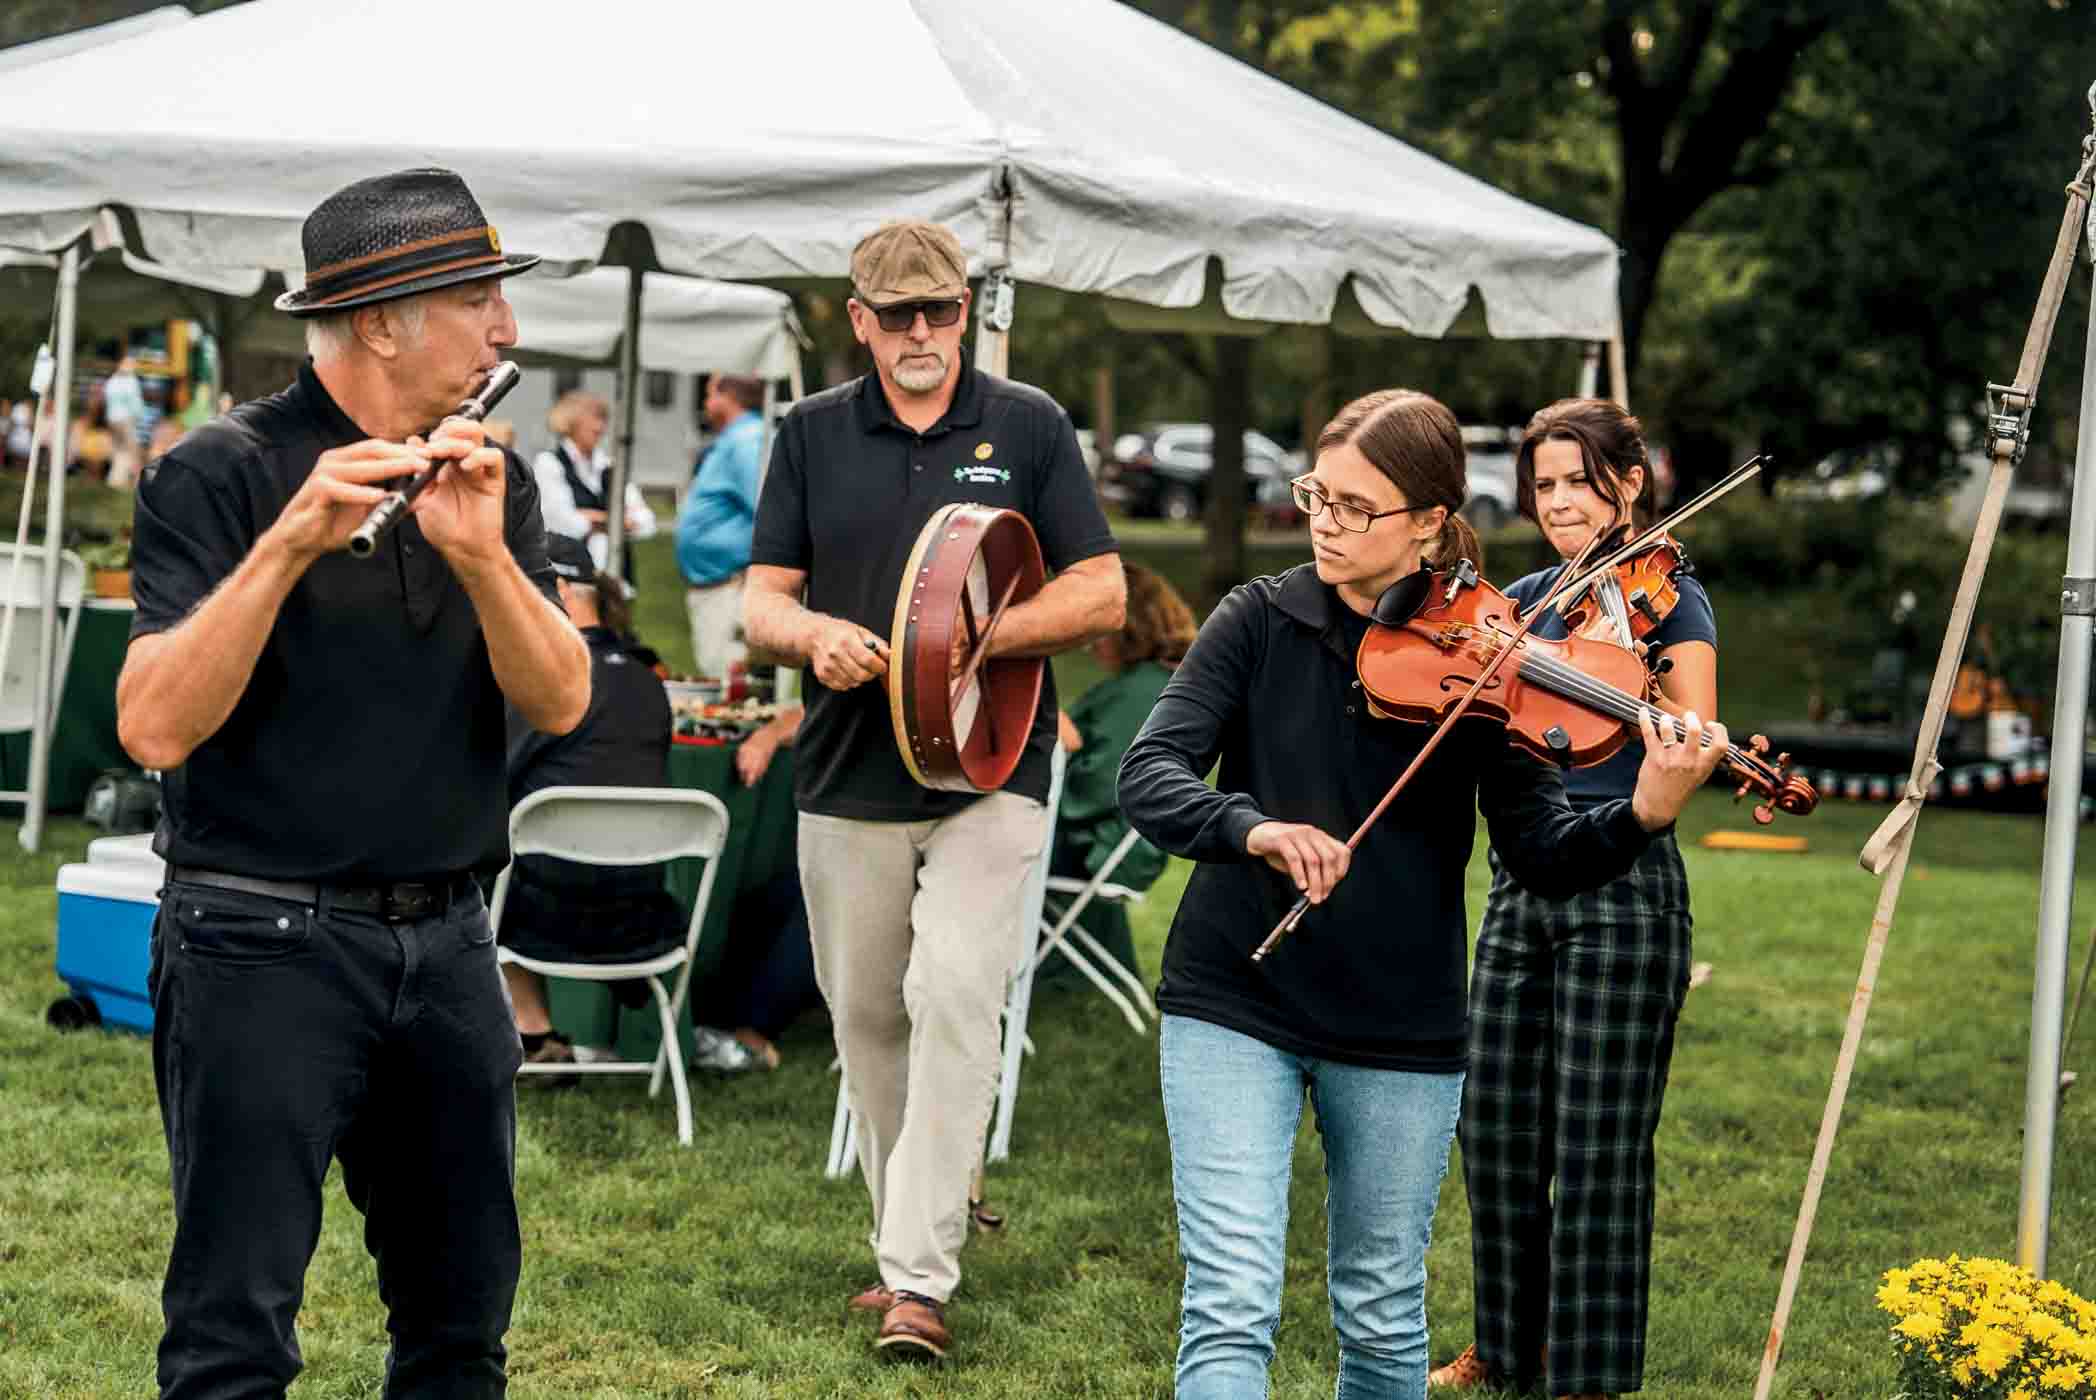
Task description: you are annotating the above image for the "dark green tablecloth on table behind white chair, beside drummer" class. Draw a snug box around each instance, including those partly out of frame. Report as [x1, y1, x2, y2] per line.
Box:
[547, 744, 799, 1060]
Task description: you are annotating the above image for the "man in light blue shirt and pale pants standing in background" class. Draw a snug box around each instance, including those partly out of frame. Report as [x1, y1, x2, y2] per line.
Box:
[677, 375, 765, 675]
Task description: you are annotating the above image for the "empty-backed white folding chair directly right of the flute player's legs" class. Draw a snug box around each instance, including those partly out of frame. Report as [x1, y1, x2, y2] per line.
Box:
[488, 786, 727, 1146]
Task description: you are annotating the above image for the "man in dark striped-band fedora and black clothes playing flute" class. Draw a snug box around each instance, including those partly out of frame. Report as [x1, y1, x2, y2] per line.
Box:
[117, 170, 589, 1400]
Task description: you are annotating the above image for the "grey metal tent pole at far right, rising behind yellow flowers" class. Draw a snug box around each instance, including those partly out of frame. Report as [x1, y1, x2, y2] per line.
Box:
[2016, 243, 2096, 1278]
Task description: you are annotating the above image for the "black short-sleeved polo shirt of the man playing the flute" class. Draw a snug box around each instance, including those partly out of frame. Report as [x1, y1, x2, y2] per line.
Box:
[132, 363, 570, 882]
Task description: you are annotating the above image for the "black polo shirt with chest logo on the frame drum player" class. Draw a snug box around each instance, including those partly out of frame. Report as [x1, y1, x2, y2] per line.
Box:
[750, 367, 1115, 822]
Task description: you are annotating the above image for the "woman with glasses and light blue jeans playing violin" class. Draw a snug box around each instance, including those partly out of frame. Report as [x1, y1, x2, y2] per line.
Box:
[1119, 390, 1723, 1400]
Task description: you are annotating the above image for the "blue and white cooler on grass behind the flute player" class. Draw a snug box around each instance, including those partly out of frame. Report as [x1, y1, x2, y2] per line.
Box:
[44, 832, 166, 1031]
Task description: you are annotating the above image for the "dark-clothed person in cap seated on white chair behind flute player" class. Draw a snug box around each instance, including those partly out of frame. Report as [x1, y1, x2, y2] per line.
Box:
[497, 534, 687, 1065]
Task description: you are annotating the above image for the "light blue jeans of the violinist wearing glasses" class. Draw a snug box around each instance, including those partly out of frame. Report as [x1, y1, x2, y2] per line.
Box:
[1159, 1016, 1463, 1400]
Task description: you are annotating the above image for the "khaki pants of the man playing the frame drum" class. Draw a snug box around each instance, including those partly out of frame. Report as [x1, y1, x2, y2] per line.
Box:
[801, 792, 1046, 1301]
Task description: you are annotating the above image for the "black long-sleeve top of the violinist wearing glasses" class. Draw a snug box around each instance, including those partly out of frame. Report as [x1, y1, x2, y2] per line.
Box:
[1119, 564, 1650, 1071]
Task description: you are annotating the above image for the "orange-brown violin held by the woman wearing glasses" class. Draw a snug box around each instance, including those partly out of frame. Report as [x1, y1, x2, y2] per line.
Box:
[1354, 560, 1819, 824]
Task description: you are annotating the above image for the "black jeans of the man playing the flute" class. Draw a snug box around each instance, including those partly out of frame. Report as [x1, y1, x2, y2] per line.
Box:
[147, 882, 524, 1400]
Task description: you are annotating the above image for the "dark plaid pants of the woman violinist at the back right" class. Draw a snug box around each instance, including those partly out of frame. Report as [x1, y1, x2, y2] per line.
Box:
[1459, 834, 1689, 1396]
